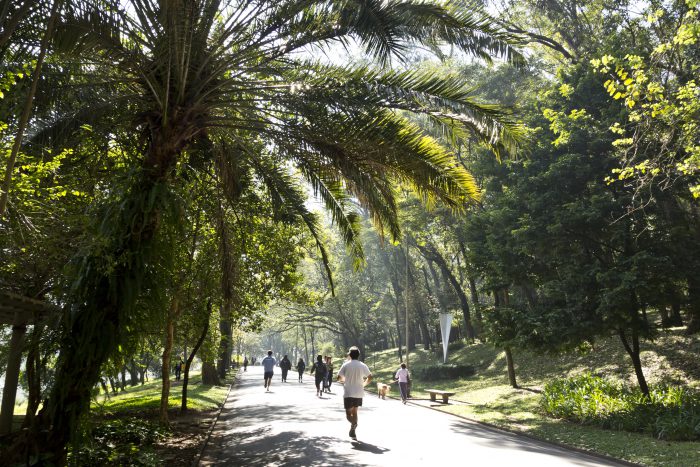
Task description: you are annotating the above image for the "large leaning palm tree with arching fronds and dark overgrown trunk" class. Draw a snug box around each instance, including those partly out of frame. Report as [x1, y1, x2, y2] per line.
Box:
[8, 0, 520, 463]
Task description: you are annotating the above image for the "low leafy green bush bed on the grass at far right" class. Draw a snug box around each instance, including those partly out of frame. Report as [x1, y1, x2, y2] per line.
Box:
[540, 374, 700, 441]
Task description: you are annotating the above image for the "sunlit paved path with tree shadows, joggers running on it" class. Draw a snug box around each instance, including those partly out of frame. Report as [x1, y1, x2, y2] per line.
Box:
[200, 366, 622, 467]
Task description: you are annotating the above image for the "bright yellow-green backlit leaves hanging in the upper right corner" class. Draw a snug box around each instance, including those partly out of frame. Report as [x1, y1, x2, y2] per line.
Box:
[591, 0, 700, 199]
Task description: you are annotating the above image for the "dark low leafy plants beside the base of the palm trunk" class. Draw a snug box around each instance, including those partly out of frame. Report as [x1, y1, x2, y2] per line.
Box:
[68, 417, 168, 466]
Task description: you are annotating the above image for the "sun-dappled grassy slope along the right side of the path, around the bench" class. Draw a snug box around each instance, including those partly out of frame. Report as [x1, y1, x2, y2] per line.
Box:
[365, 329, 700, 467]
